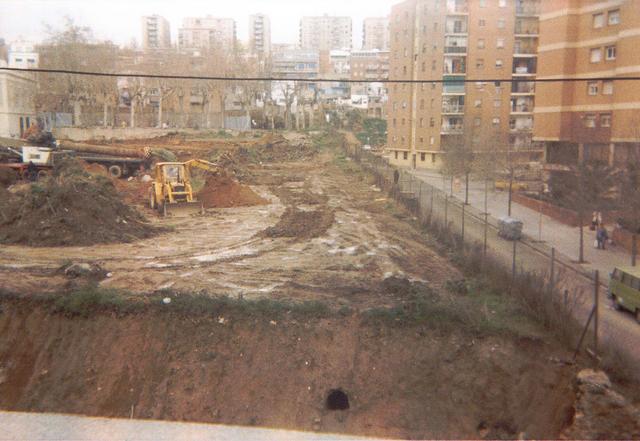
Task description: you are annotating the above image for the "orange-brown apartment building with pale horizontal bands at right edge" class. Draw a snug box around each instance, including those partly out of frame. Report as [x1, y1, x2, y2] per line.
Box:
[534, 0, 640, 168]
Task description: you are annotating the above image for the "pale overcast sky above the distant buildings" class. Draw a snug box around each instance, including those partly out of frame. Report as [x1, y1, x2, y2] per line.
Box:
[0, 0, 400, 48]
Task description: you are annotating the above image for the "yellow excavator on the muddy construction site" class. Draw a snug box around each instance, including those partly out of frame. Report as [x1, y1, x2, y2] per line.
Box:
[149, 159, 222, 216]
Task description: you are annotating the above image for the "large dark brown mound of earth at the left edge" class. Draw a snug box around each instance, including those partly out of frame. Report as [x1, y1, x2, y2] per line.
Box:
[0, 164, 158, 246]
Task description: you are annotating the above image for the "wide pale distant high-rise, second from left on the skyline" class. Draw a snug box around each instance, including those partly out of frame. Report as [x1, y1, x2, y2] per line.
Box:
[178, 15, 236, 52]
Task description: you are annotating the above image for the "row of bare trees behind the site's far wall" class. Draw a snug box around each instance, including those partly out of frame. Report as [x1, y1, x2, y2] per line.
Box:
[37, 18, 268, 127]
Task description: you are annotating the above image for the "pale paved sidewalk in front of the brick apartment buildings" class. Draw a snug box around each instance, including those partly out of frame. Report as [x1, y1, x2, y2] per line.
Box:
[407, 170, 631, 280]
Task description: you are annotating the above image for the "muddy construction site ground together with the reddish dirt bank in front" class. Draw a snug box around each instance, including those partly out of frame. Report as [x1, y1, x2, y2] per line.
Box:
[0, 132, 636, 439]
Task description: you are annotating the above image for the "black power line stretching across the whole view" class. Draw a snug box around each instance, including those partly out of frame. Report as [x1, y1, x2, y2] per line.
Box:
[0, 67, 640, 84]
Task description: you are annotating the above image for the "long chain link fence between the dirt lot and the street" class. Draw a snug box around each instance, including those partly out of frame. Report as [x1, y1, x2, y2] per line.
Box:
[344, 143, 640, 368]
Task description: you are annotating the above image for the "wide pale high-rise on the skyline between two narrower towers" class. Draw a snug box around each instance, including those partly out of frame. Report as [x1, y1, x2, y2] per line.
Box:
[300, 14, 353, 51]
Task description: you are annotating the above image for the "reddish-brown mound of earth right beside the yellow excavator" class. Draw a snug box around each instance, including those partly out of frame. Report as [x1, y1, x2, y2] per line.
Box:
[198, 175, 269, 208]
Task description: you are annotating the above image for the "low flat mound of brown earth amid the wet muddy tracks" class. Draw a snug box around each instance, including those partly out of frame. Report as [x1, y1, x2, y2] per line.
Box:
[263, 207, 335, 239]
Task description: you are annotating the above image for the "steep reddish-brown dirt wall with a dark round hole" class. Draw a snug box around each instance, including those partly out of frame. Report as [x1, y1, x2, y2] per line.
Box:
[0, 300, 573, 438]
